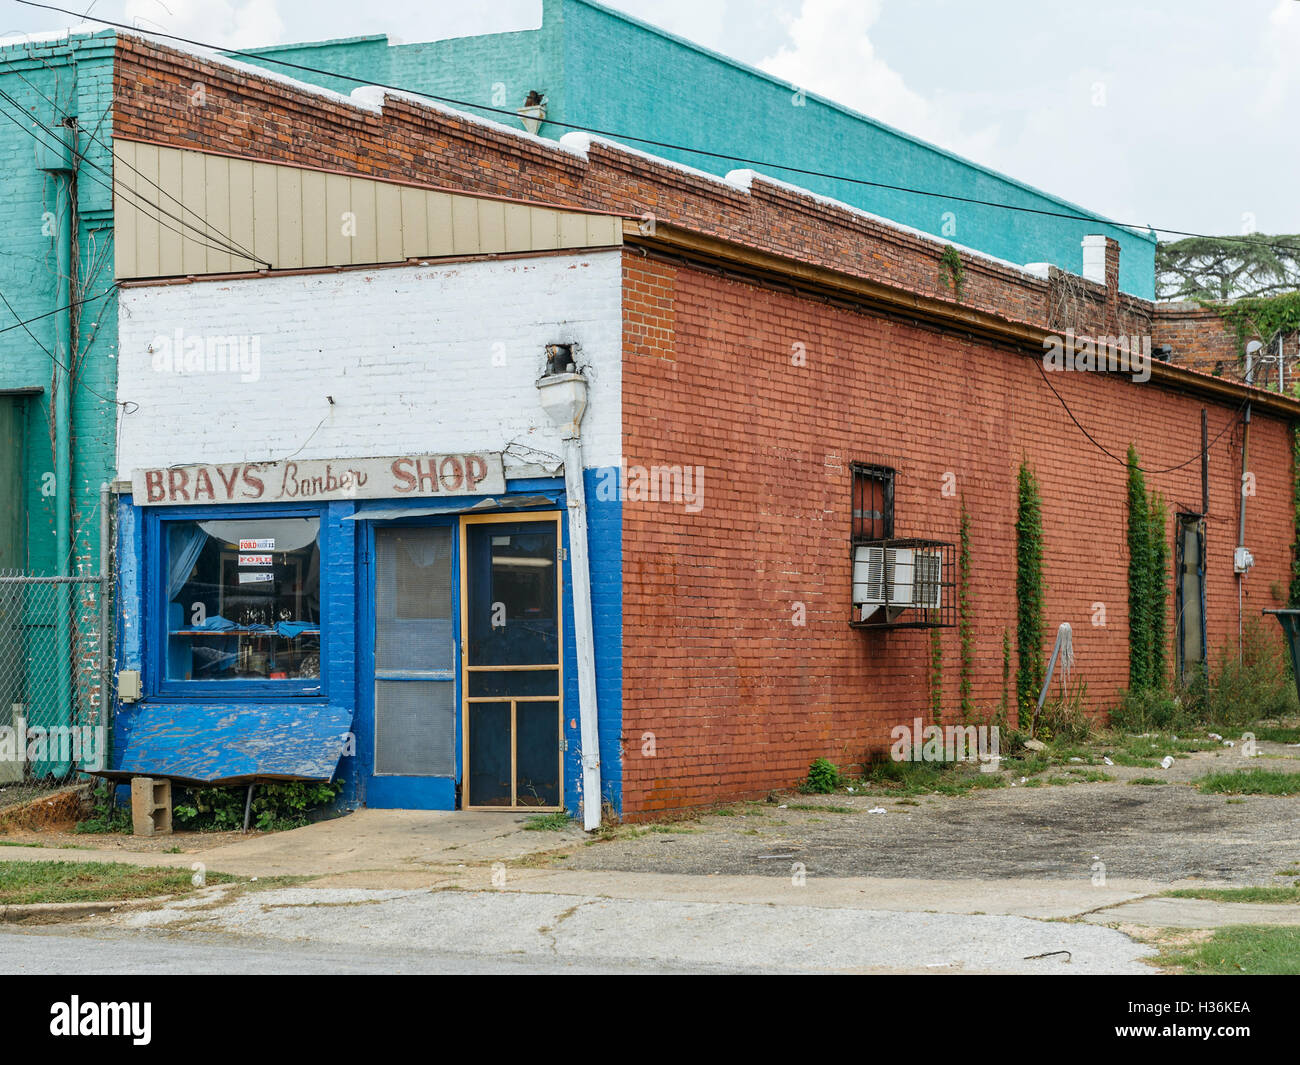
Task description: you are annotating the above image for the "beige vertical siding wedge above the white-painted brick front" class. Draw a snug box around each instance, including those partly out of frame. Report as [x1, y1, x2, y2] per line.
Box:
[114, 140, 623, 280]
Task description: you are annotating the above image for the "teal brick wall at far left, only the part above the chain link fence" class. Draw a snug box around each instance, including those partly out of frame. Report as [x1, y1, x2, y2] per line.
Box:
[0, 33, 117, 573]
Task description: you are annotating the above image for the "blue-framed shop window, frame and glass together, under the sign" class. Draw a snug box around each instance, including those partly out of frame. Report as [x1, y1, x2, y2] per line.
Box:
[146, 506, 329, 701]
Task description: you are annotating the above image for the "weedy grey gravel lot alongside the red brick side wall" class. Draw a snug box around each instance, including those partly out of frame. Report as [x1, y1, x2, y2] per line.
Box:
[569, 750, 1300, 886]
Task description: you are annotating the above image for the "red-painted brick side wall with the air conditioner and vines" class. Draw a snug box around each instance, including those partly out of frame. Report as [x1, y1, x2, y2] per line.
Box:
[623, 252, 1292, 817]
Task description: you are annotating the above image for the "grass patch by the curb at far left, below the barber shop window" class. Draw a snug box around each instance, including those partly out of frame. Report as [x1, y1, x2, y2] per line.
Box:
[0, 862, 239, 906]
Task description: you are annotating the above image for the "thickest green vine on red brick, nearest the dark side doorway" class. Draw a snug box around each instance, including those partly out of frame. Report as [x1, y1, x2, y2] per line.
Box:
[1128, 445, 1169, 692]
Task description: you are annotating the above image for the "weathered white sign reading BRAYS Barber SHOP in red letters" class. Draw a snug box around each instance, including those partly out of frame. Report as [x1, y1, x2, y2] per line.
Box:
[131, 451, 506, 507]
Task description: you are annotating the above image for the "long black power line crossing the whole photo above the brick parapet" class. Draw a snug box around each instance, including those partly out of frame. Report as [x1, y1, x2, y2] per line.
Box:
[16, 0, 1288, 256]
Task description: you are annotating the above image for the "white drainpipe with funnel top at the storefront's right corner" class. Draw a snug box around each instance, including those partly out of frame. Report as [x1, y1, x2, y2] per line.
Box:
[537, 372, 601, 832]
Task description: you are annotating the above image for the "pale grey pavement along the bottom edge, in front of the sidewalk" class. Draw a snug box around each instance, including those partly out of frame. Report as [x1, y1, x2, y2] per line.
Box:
[0, 887, 1154, 975]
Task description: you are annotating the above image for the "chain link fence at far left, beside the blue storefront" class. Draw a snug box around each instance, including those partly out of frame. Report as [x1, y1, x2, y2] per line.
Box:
[0, 572, 112, 815]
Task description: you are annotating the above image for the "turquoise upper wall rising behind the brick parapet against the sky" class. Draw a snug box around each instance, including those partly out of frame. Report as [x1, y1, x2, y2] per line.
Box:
[241, 0, 1156, 299]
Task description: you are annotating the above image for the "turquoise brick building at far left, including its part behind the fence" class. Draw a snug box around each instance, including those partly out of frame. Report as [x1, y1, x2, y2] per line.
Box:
[0, 25, 117, 784]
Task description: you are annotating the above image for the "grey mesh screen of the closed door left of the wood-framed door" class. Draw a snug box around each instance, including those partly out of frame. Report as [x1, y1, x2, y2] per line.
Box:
[374, 525, 456, 776]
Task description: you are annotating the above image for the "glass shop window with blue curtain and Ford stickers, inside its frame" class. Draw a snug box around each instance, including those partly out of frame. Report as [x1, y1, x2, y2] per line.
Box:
[161, 518, 321, 683]
